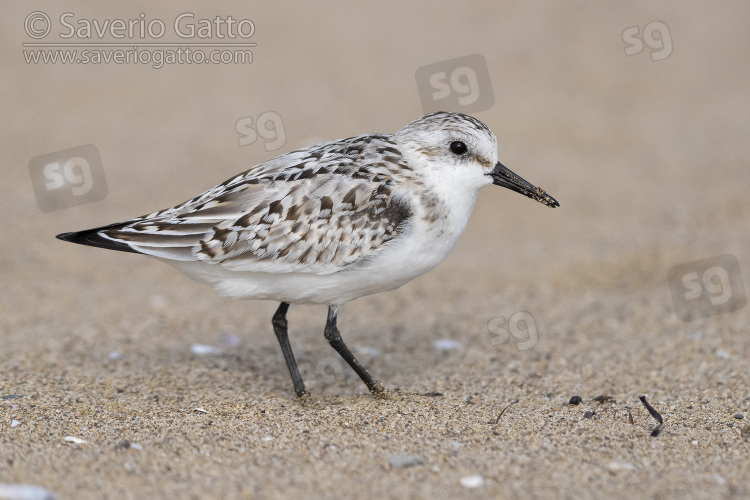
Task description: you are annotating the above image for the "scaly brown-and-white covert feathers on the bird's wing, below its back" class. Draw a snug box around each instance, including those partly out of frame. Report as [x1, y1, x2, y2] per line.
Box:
[196, 175, 408, 274]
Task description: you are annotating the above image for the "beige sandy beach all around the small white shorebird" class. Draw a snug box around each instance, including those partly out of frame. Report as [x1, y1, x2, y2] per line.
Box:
[0, 1, 750, 499]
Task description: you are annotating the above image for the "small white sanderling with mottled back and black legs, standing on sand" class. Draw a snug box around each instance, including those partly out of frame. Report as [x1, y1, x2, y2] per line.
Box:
[57, 112, 559, 396]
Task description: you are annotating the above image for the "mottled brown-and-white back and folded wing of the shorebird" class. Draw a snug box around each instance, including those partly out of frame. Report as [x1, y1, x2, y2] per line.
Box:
[75, 136, 410, 274]
